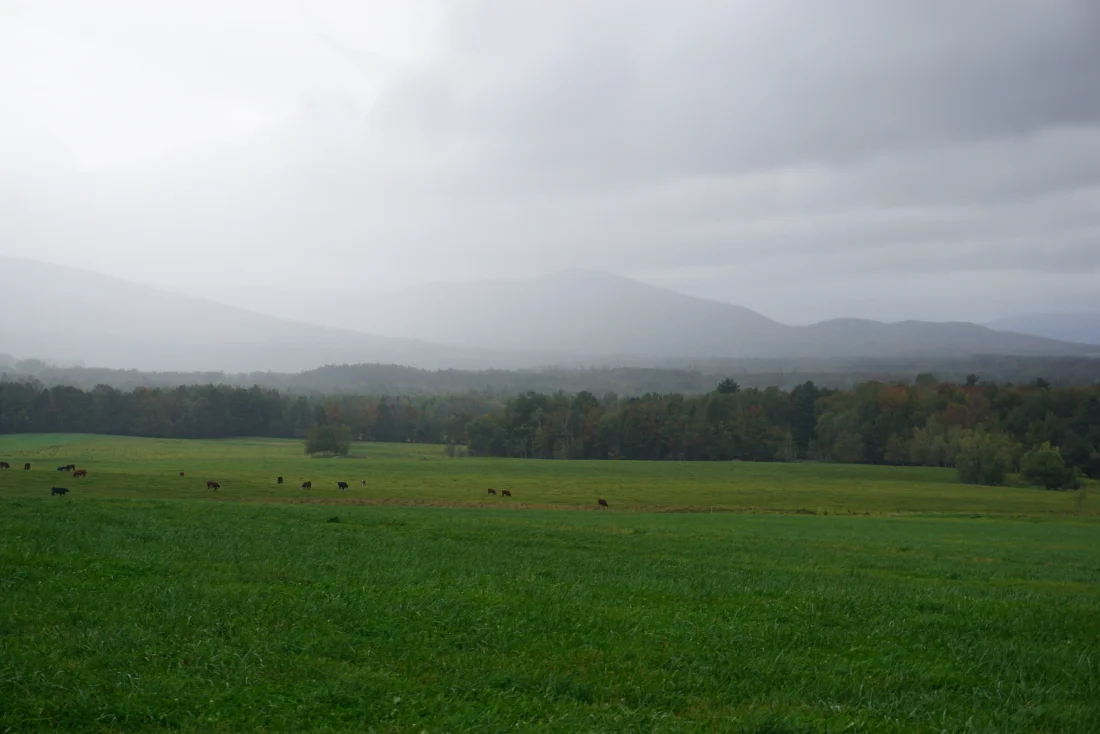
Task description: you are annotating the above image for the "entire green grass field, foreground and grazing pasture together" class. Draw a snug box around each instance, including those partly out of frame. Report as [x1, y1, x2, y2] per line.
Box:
[0, 436, 1100, 733]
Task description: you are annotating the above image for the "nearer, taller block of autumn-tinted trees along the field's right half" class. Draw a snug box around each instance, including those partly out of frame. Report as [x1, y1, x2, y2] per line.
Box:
[466, 375, 1100, 483]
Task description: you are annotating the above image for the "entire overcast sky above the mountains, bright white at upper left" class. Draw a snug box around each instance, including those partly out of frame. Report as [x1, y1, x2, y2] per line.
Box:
[0, 0, 1100, 322]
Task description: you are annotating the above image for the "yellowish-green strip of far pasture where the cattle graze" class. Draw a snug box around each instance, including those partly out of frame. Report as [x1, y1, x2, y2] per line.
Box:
[0, 435, 1086, 516]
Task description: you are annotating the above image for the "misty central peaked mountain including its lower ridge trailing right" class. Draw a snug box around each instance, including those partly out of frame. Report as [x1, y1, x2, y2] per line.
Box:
[180, 271, 1100, 364]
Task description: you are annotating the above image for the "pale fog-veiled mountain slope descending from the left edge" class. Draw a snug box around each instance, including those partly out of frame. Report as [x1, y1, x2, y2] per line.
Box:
[0, 259, 536, 372]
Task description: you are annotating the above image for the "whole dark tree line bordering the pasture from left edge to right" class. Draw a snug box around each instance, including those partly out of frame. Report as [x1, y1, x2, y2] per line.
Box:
[0, 375, 1100, 478]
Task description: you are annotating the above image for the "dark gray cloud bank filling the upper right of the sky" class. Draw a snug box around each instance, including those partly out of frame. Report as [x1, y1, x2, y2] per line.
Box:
[374, 0, 1100, 177]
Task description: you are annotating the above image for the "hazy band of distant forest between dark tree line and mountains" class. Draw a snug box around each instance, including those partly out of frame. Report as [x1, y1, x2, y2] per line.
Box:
[0, 354, 1100, 397]
